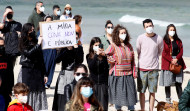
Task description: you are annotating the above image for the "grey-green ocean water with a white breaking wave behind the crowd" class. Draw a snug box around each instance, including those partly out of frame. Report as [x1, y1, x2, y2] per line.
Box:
[0, 0, 190, 57]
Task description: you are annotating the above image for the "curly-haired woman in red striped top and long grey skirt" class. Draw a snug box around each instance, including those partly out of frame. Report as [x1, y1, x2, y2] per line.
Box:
[105, 25, 137, 111]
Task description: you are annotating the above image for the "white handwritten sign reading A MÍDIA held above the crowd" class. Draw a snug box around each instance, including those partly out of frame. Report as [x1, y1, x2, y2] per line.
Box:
[40, 19, 76, 49]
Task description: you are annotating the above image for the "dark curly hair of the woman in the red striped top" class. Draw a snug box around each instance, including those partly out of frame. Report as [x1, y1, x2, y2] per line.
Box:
[112, 24, 131, 46]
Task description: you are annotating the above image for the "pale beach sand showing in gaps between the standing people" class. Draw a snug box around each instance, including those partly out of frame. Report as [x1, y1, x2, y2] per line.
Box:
[14, 44, 190, 111]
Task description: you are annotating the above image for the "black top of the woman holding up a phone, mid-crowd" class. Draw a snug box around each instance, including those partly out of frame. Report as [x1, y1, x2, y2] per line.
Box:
[86, 54, 109, 84]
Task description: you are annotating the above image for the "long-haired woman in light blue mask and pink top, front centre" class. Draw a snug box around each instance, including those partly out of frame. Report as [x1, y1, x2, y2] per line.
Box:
[65, 77, 103, 111]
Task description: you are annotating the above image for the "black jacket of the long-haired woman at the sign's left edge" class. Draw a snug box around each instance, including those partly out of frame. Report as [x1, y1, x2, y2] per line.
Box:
[20, 44, 47, 91]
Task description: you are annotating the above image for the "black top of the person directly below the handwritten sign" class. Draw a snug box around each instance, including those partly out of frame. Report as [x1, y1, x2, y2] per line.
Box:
[56, 45, 84, 70]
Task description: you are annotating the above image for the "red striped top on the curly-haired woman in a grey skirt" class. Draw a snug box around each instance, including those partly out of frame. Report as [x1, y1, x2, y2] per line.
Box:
[105, 44, 136, 76]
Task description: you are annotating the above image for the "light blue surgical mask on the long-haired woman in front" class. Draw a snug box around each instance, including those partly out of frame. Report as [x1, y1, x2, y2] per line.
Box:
[81, 86, 93, 98]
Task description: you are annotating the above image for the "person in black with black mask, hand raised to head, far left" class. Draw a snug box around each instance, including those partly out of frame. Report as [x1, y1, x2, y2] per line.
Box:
[0, 6, 22, 93]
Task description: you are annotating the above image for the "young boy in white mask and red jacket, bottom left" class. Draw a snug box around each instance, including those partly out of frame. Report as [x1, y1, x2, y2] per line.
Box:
[7, 83, 33, 111]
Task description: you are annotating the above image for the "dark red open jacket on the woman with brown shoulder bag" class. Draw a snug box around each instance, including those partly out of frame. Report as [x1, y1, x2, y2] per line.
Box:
[162, 40, 186, 70]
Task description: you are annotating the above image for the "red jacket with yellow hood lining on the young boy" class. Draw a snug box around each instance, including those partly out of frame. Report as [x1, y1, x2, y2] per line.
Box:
[7, 99, 33, 111]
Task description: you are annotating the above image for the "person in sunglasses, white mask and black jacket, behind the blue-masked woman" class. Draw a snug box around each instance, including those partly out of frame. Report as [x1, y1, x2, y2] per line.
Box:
[60, 64, 88, 111]
